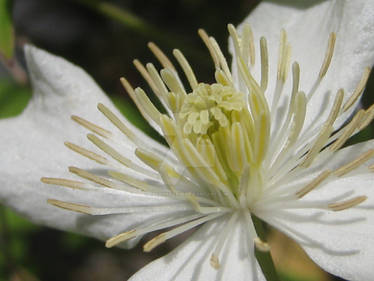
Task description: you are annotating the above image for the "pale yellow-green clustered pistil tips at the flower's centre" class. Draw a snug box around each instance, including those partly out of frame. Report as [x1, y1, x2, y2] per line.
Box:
[179, 83, 245, 136]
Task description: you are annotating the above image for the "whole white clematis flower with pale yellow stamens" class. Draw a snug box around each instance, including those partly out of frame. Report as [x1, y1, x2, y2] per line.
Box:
[0, 1, 374, 280]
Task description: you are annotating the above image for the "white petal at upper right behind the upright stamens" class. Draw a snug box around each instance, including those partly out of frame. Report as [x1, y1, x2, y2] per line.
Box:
[233, 0, 374, 131]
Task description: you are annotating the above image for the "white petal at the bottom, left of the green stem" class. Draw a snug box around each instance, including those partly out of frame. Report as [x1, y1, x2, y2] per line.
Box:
[130, 218, 265, 281]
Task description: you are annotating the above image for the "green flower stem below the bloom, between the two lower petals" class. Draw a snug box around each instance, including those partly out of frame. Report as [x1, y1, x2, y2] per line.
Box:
[252, 215, 279, 281]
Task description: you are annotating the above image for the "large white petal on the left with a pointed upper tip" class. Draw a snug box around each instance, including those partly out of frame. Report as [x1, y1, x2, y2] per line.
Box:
[0, 46, 175, 245]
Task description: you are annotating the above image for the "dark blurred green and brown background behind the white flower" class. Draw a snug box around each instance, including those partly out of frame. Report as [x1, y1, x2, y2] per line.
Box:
[0, 0, 374, 281]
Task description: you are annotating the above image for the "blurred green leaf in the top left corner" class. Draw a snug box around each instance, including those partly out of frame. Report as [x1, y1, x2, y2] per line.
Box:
[0, 0, 14, 59]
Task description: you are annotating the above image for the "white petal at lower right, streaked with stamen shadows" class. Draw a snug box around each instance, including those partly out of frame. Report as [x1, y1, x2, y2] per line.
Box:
[260, 141, 374, 281]
